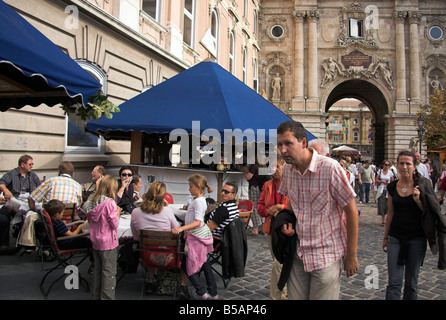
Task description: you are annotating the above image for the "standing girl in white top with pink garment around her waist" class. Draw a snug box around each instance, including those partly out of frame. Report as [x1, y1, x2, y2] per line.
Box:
[172, 174, 218, 300]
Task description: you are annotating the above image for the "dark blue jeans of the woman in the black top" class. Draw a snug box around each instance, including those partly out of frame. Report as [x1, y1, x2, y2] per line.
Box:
[386, 236, 427, 300]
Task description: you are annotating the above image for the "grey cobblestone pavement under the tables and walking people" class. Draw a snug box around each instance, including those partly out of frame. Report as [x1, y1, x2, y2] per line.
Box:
[0, 198, 446, 300]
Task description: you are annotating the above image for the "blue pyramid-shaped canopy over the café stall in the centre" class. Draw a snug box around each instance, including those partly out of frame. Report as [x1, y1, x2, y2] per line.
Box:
[87, 62, 315, 142]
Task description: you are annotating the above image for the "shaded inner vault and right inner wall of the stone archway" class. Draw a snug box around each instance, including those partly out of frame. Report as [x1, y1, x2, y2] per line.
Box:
[325, 79, 389, 163]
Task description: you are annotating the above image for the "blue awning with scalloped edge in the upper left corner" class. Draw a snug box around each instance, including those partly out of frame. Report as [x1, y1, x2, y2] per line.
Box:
[0, 0, 102, 111]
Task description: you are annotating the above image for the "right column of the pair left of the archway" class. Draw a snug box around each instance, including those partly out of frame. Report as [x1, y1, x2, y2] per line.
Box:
[307, 10, 319, 111]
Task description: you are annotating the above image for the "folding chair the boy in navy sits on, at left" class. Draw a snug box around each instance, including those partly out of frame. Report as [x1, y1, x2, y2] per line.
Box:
[39, 210, 89, 298]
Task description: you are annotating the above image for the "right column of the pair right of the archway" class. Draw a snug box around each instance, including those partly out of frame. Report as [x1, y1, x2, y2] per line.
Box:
[408, 11, 421, 106]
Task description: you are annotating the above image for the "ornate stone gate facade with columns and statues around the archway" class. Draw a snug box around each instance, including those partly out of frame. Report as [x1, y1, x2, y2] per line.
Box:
[260, 0, 446, 161]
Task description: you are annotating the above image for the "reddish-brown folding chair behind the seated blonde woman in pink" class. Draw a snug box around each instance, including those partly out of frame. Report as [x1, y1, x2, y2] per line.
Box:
[139, 229, 185, 299]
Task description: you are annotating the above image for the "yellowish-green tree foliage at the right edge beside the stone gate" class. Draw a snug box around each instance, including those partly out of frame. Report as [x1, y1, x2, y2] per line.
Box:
[417, 89, 446, 149]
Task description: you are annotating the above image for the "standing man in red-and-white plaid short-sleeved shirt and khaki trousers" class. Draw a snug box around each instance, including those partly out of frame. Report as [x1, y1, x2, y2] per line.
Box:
[277, 120, 358, 300]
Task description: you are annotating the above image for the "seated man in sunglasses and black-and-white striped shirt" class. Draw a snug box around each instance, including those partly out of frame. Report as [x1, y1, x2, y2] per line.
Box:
[206, 182, 239, 241]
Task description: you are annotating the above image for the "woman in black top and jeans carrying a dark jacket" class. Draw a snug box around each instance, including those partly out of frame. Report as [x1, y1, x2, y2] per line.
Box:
[382, 151, 446, 300]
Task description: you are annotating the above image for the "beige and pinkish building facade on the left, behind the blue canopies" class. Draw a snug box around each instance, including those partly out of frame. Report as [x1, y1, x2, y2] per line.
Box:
[0, 0, 260, 182]
